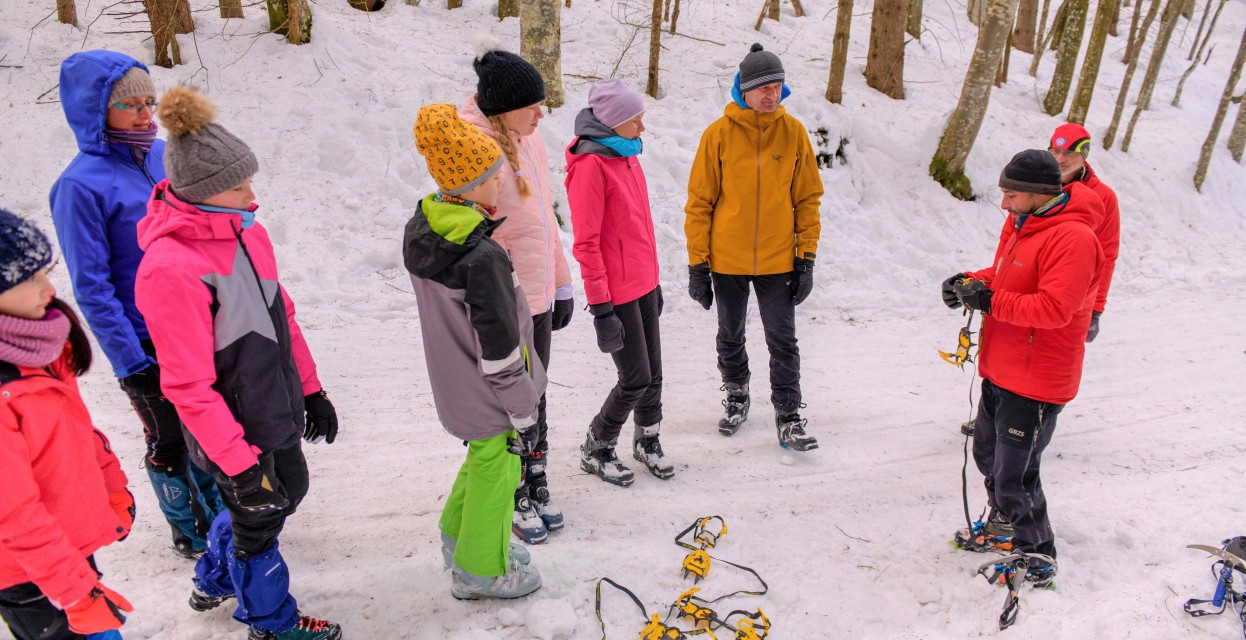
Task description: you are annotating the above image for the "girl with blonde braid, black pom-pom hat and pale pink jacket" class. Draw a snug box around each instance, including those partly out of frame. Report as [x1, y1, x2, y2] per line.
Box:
[460, 36, 574, 544]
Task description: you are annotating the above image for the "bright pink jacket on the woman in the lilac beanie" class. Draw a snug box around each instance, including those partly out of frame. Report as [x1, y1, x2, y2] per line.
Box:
[566, 137, 658, 305]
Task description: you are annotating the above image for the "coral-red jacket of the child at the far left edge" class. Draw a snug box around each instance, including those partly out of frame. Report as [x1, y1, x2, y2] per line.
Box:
[0, 346, 126, 606]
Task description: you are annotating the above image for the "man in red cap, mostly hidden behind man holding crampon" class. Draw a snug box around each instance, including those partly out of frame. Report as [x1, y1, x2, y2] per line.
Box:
[1047, 122, 1120, 342]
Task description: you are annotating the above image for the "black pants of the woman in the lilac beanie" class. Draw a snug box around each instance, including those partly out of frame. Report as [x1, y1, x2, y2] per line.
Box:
[592, 286, 663, 442]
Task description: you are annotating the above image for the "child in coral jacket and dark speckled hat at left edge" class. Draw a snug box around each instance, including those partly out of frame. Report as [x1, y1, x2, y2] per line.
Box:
[0, 209, 135, 632]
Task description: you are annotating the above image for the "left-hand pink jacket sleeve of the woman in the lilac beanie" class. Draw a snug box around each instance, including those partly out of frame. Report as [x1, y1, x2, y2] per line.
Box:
[567, 157, 611, 305]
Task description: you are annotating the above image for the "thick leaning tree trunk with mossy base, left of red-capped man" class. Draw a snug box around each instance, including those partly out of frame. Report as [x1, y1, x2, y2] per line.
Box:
[930, 0, 1019, 200]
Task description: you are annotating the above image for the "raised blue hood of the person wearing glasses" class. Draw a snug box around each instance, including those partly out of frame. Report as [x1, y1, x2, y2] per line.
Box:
[61, 50, 147, 156]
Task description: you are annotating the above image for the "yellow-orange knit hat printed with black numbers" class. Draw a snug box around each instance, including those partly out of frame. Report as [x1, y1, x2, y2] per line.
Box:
[414, 103, 503, 195]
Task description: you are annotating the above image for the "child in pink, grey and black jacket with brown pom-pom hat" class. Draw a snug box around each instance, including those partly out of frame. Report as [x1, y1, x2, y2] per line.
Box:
[135, 87, 341, 640]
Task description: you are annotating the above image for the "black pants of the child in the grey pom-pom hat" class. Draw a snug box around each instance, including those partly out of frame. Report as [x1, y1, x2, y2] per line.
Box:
[216, 441, 310, 558]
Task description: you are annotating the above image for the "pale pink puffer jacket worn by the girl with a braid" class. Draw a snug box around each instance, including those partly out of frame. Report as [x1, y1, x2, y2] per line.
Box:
[459, 96, 571, 315]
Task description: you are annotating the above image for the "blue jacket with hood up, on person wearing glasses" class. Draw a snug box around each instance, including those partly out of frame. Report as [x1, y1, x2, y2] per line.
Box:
[49, 51, 164, 377]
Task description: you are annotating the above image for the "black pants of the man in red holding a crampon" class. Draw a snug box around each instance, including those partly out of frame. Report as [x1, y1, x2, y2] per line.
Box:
[973, 379, 1064, 558]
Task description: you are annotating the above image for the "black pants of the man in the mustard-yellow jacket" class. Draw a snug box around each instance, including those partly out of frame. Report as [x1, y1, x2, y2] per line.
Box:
[711, 273, 801, 415]
